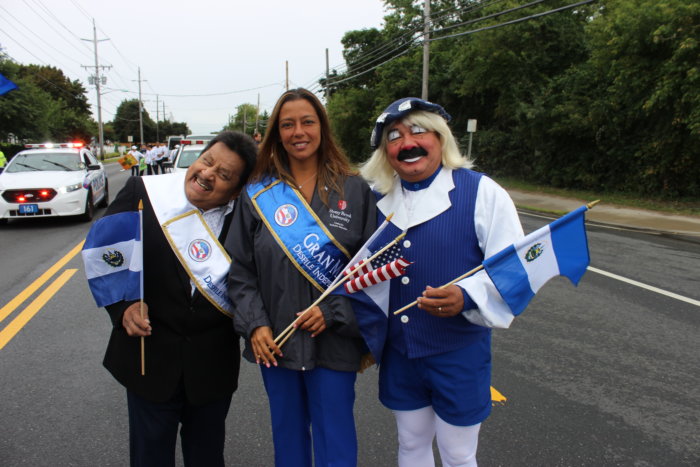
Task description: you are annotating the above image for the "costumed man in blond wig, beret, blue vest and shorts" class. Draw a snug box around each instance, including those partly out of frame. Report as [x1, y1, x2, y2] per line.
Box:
[360, 97, 523, 467]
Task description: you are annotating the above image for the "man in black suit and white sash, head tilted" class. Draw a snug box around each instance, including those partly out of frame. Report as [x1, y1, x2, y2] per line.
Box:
[104, 131, 256, 467]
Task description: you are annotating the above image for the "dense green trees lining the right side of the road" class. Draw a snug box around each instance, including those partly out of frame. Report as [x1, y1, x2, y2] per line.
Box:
[322, 0, 700, 198]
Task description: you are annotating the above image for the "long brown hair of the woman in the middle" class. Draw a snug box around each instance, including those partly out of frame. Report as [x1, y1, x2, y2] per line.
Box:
[251, 88, 356, 205]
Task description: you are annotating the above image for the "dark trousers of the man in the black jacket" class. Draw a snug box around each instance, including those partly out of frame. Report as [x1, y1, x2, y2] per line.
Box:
[126, 383, 231, 467]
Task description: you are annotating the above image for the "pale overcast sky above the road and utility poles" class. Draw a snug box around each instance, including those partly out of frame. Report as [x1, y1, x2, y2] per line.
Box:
[0, 0, 386, 134]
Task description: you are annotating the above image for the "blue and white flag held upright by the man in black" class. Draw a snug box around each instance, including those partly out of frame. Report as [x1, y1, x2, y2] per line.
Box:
[82, 211, 143, 307]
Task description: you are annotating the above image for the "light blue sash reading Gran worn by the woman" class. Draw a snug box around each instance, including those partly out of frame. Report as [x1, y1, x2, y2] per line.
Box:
[246, 179, 350, 291]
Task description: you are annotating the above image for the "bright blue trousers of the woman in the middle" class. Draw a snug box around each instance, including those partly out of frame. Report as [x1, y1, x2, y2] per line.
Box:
[261, 366, 357, 467]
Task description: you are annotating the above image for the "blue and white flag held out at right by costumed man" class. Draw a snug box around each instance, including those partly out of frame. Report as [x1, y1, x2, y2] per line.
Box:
[483, 206, 590, 316]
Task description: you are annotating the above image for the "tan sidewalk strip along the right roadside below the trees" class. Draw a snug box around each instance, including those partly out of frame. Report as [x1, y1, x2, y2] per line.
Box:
[508, 190, 700, 243]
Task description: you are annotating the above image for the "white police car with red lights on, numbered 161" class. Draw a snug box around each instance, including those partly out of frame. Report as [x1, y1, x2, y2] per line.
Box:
[0, 143, 109, 222]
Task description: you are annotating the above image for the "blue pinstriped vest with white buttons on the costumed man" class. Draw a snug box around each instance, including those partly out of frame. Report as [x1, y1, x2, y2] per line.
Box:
[379, 169, 490, 358]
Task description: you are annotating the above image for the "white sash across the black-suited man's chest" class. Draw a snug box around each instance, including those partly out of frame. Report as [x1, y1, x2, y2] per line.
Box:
[143, 172, 233, 316]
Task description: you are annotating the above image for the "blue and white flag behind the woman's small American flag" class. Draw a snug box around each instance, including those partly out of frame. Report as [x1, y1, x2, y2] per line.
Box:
[331, 221, 400, 363]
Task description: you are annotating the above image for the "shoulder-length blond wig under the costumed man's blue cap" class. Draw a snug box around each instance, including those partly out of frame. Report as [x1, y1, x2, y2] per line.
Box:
[360, 110, 474, 195]
